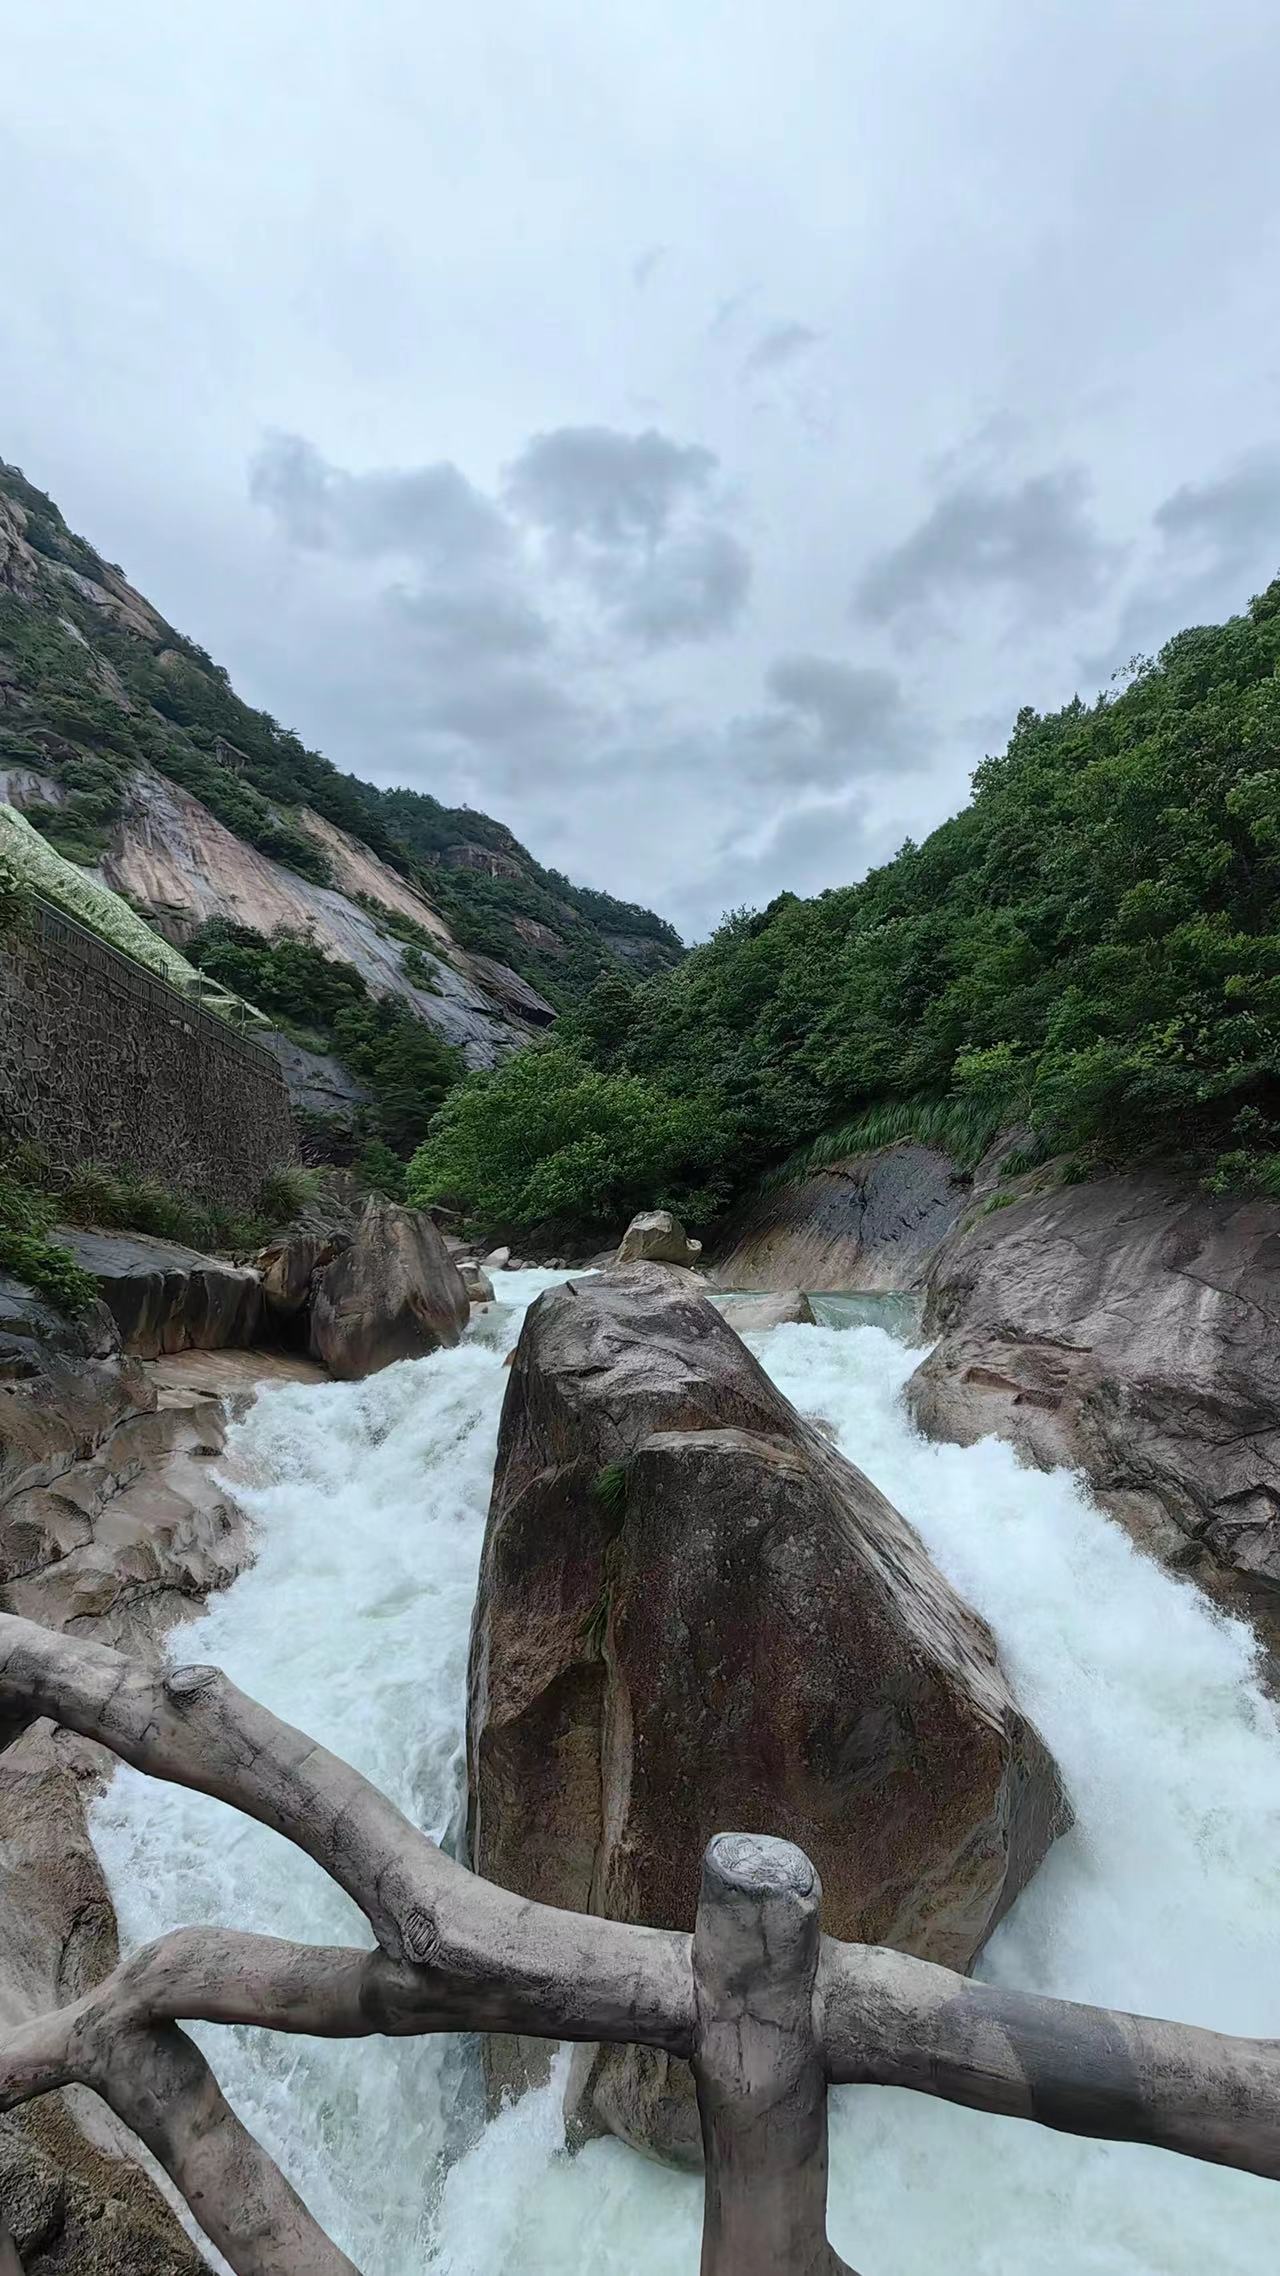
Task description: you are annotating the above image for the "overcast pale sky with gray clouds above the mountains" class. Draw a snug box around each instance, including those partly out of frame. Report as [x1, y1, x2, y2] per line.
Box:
[0, 0, 1280, 935]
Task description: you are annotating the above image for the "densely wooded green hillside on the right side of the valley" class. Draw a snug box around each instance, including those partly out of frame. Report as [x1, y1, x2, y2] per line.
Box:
[415, 583, 1280, 1218]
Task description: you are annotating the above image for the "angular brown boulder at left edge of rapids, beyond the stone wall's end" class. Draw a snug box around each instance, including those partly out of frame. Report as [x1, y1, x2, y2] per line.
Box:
[310, 1195, 471, 1382]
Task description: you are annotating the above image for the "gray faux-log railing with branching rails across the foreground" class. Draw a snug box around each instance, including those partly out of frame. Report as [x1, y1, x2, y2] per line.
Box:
[0, 1616, 1280, 2276]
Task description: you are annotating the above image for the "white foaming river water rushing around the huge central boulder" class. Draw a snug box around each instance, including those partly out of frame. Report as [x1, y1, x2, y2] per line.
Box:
[96, 1272, 1280, 2276]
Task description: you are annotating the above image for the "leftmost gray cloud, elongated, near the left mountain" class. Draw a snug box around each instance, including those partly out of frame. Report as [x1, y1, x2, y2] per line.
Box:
[248, 435, 508, 569]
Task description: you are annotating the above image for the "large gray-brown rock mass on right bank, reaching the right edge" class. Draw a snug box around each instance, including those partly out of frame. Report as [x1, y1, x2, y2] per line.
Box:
[909, 1174, 1280, 1625]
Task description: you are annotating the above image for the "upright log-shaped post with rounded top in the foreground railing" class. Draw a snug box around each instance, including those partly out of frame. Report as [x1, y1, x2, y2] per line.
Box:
[692, 1834, 852, 2276]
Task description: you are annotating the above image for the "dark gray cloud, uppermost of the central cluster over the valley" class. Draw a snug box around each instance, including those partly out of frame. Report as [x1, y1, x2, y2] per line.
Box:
[506, 426, 717, 546]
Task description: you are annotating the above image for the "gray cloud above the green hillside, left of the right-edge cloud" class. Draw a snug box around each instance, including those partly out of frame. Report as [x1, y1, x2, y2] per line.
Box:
[854, 467, 1121, 624]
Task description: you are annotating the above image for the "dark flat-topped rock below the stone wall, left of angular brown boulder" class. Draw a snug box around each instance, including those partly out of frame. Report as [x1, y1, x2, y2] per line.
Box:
[57, 1224, 262, 1359]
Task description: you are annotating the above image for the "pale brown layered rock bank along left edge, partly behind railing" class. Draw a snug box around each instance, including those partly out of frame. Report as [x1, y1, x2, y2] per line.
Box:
[0, 1293, 264, 2276]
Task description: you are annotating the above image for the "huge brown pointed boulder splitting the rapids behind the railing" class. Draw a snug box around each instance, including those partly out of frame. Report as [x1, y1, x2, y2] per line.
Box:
[469, 1265, 1068, 2162]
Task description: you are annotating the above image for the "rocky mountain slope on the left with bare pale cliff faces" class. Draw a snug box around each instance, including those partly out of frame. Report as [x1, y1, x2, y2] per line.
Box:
[0, 462, 683, 1067]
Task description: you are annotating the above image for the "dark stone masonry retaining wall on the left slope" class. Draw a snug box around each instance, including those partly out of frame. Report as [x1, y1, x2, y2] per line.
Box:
[0, 901, 294, 1206]
